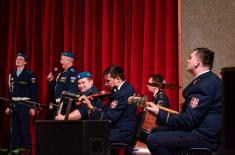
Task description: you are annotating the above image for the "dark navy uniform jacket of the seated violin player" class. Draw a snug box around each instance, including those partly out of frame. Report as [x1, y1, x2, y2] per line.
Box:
[91, 81, 137, 144]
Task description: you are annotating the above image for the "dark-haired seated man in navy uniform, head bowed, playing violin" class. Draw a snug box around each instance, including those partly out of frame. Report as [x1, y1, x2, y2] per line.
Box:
[79, 66, 137, 144]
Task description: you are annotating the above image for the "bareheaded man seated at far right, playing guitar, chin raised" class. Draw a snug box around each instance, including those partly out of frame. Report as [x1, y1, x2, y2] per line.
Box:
[147, 48, 222, 155]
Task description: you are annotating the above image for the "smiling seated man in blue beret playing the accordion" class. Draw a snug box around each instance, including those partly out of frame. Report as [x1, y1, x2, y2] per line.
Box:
[55, 72, 102, 120]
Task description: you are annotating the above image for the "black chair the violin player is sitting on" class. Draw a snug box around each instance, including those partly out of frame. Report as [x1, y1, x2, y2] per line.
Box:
[110, 111, 144, 155]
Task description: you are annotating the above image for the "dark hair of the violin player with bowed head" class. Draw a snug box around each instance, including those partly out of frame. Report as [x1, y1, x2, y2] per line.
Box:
[103, 65, 125, 80]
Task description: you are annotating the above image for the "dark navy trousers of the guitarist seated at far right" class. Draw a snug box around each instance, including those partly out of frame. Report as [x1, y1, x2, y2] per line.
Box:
[146, 126, 218, 155]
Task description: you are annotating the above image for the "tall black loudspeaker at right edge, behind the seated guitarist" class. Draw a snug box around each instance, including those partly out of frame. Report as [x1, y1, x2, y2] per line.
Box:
[221, 67, 235, 155]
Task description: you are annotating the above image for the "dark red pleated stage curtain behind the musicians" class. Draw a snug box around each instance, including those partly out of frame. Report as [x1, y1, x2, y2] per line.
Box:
[0, 0, 178, 153]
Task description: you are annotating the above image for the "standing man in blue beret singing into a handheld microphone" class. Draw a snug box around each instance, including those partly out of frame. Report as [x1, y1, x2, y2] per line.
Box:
[47, 52, 78, 119]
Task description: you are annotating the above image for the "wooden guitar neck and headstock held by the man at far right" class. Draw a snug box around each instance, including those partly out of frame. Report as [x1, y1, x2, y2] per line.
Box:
[128, 96, 179, 114]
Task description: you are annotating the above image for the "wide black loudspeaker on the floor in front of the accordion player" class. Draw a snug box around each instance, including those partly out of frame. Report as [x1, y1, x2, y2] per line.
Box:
[35, 120, 110, 155]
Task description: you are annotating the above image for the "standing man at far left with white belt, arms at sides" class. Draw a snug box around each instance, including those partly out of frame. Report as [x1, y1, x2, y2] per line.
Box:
[6, 52, 38, 153]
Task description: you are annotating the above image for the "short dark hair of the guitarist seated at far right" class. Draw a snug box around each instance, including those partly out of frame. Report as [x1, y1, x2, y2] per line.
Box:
[193, 48, 214, 69]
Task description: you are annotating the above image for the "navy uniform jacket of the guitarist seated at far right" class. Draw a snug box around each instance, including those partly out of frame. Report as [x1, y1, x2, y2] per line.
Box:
[158, 71, 222, 142]
